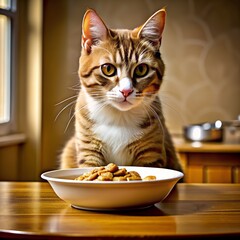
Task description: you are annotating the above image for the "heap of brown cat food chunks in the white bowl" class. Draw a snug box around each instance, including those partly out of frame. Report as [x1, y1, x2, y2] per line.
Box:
[75, 163, 156, 181]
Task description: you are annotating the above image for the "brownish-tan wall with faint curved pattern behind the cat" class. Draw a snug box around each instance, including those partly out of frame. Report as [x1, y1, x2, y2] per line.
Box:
[41, 0, 240, 171]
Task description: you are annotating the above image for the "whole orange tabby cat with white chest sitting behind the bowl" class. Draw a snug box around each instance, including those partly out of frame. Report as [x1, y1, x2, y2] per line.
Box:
[60, 9, 182, 171]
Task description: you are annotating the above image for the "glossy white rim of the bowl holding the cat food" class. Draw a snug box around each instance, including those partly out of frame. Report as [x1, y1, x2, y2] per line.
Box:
[41, 166, 184, 185]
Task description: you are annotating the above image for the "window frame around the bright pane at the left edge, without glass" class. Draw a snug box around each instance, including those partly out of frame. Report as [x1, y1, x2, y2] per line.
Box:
[0, 0, 18, 136]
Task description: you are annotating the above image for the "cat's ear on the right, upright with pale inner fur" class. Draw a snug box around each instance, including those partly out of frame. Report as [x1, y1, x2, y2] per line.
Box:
[133, 8, 166, 47]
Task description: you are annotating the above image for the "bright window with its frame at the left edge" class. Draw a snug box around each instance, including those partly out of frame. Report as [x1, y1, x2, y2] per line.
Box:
[0, 0, 16, 135]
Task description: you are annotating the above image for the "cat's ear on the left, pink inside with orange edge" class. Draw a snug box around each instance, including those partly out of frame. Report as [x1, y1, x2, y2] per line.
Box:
[82, 9, 108, 54]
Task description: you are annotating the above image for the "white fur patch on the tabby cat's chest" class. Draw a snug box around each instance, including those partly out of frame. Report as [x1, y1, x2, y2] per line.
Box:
[89, 95, 143, 165]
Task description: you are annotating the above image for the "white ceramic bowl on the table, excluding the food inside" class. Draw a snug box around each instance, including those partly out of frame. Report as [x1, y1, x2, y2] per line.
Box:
[41, 166, 183, 210]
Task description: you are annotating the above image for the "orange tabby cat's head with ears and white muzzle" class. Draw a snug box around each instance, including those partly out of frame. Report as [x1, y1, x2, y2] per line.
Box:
[79, 9, 166, 111]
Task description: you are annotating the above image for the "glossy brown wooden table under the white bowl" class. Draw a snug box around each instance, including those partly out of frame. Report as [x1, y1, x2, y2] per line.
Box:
[0, 182, 240, 239]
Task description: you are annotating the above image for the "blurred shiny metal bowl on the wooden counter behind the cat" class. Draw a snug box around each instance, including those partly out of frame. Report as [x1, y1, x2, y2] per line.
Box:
[183, 120, 223, 142]
